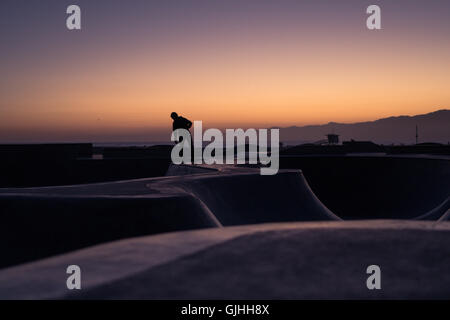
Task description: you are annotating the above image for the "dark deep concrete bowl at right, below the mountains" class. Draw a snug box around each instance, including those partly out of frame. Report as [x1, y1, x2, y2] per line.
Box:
[280, 155, 450, 220]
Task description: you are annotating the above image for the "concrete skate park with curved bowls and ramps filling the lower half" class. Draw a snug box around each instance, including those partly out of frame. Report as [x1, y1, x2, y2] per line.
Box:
[0, 151, 450, 299]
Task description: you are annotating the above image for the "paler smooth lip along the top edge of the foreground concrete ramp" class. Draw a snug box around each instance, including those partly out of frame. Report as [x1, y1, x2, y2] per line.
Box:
[0, 220, 450, 299]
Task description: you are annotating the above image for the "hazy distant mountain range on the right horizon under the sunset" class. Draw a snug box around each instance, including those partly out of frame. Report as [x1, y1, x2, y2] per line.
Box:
[280, 110, 450, 144]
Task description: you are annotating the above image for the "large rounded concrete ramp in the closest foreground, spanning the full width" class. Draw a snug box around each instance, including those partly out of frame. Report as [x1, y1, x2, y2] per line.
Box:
[0, 220, 450, 299]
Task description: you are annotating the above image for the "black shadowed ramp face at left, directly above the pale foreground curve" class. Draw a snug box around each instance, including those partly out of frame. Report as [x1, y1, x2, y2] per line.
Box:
[0, 194, 220, 268]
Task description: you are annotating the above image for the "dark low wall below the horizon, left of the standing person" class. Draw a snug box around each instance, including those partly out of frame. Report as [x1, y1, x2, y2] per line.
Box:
[0, 143, 171, 188]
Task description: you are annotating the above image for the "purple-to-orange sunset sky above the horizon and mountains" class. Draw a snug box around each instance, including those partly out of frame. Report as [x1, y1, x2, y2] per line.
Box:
[0, 0, 450, 143]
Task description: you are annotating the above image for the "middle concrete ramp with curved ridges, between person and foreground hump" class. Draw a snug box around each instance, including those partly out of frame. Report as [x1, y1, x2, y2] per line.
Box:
[0, 168, 339, 268]
